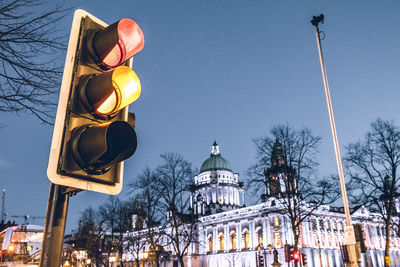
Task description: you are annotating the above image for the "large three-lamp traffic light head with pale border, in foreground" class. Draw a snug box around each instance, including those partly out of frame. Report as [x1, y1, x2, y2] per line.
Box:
[47, 10, 144, 195]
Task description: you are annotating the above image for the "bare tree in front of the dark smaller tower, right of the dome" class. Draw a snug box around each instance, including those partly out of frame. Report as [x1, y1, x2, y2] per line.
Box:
[248, 124, 340, 249]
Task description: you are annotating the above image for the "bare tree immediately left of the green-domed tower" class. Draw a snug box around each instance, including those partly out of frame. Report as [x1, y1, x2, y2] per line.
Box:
[155, 153, 197, 267]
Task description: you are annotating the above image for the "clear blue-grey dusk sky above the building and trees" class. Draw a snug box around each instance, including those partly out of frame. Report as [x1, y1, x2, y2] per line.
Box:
[0, 0, 400, 232]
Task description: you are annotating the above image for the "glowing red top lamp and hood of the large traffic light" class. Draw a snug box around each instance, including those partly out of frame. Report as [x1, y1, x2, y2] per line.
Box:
[87, 19, 144, 69]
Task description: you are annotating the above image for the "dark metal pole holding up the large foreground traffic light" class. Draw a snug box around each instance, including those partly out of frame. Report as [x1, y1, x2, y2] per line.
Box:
[39, 183, 69, 267]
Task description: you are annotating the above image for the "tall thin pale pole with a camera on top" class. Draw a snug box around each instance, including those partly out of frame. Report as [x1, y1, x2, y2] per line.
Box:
[311, 14, 358, 267]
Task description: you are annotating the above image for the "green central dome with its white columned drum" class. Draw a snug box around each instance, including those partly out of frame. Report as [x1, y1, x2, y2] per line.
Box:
[190, 142, 244, 216]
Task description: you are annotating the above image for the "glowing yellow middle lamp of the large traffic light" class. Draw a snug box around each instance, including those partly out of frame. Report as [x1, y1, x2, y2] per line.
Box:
[97, 66, 141, 114]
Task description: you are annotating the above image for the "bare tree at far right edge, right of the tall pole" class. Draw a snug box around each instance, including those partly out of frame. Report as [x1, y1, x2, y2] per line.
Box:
[345, 119, 400, 266]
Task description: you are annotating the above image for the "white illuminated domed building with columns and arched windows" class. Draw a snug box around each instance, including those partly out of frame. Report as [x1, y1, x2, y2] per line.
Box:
[127, 142, 400, 267]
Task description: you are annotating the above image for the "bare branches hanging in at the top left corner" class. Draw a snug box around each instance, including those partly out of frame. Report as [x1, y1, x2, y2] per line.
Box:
[0, 0, 68, 123]
